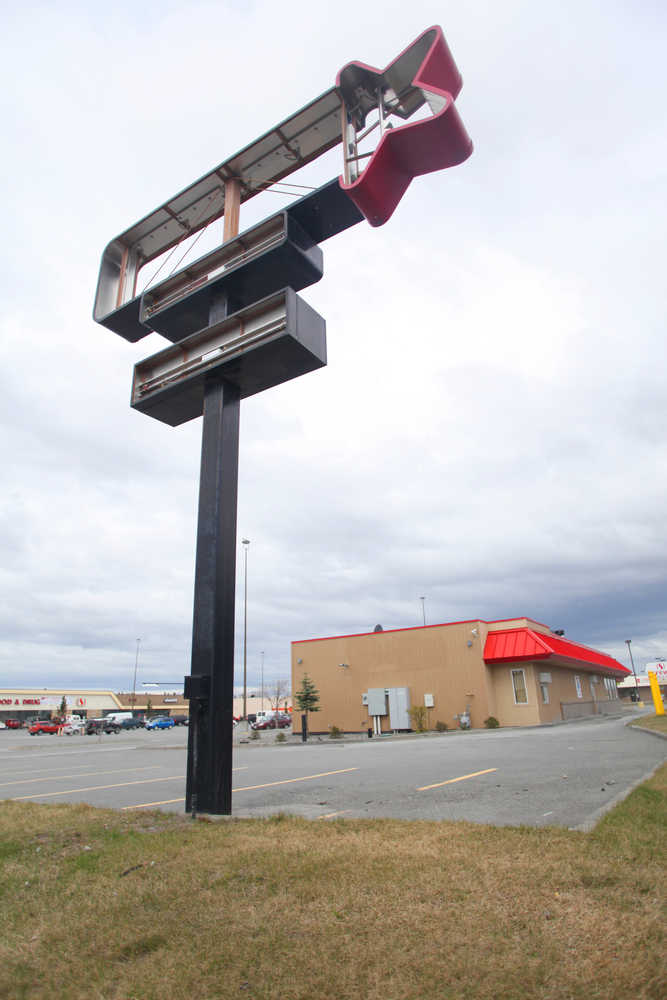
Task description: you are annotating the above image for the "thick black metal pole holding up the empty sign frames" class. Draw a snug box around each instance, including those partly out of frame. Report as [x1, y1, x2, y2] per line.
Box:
[185, 300, 240, 815]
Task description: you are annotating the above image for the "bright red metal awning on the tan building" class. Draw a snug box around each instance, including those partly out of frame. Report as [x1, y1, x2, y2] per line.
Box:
[484, 628, 630, 677]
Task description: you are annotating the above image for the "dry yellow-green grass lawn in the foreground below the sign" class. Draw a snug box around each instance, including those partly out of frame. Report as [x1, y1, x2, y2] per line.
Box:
[0, 766, 667, 1000]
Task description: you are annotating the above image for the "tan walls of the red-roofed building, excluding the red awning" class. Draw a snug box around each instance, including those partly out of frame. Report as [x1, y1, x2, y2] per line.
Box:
[292, 618, 628, 732]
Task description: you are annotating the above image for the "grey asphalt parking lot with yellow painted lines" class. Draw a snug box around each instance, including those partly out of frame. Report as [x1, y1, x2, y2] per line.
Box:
[0, 718, 667, 828]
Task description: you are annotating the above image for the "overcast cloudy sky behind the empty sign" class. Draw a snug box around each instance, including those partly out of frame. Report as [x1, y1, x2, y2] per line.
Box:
[0, 0, 667, 689]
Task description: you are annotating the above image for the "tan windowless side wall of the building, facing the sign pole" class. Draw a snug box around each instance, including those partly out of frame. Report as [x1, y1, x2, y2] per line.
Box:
[292, 621, 490, 732]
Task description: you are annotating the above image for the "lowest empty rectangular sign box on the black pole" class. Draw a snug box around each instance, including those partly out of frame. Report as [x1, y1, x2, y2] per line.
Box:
[131, 288, 327, 427]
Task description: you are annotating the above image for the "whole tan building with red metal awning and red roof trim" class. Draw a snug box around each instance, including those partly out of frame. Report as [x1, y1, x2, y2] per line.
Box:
[292, 618, 629, 733]
